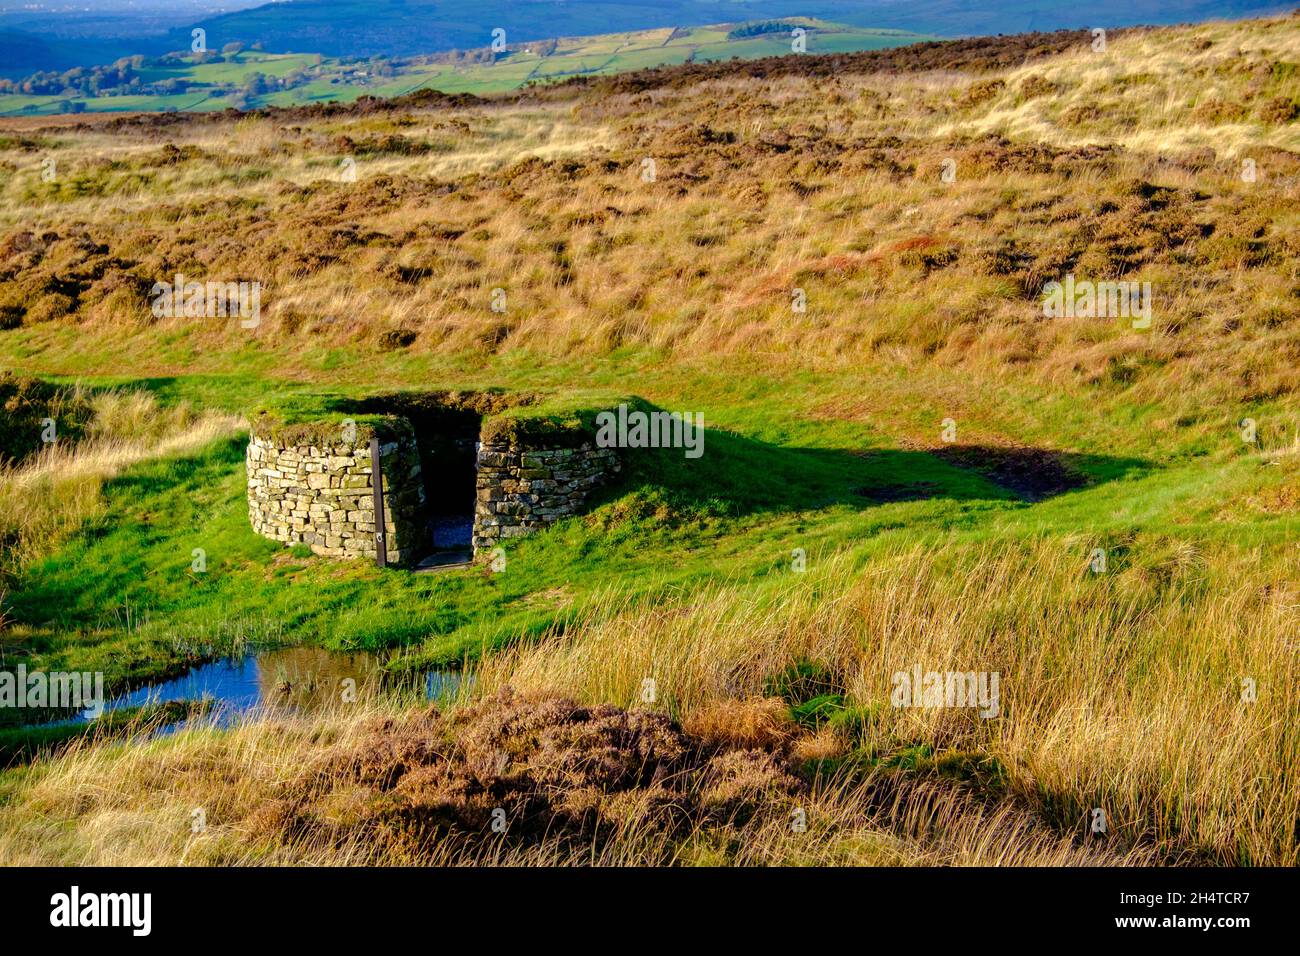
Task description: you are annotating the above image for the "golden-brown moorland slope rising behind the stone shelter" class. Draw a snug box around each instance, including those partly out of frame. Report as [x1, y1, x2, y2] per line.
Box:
[0, 17, 1300, 429]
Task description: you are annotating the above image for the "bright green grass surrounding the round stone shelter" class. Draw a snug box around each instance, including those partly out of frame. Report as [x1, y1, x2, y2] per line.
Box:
[7, 348, 1296, 684]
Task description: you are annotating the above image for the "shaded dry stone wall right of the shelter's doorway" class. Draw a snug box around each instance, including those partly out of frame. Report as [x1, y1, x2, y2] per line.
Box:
[473, 442, 621, 553]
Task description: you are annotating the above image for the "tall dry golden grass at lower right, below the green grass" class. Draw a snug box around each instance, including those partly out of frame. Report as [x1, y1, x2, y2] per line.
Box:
[476, 542, 1300, 866]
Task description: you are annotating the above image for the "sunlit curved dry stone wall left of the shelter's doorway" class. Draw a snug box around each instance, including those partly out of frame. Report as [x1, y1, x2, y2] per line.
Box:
[246, 434, 424, 563]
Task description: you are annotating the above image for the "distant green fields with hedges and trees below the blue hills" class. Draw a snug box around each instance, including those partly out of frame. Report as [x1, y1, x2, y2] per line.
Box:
[0, 17, 935, 116]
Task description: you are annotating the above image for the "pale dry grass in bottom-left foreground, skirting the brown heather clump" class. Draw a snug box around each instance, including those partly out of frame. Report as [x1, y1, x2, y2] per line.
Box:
[0, 702, 1151, 866]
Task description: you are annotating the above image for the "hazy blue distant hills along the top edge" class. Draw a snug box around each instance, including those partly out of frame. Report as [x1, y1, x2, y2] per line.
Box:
[0, 0, 1294, 77]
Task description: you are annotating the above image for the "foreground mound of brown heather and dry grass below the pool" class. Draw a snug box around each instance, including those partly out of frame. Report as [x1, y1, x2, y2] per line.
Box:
[0, 692, 1151, 865]
